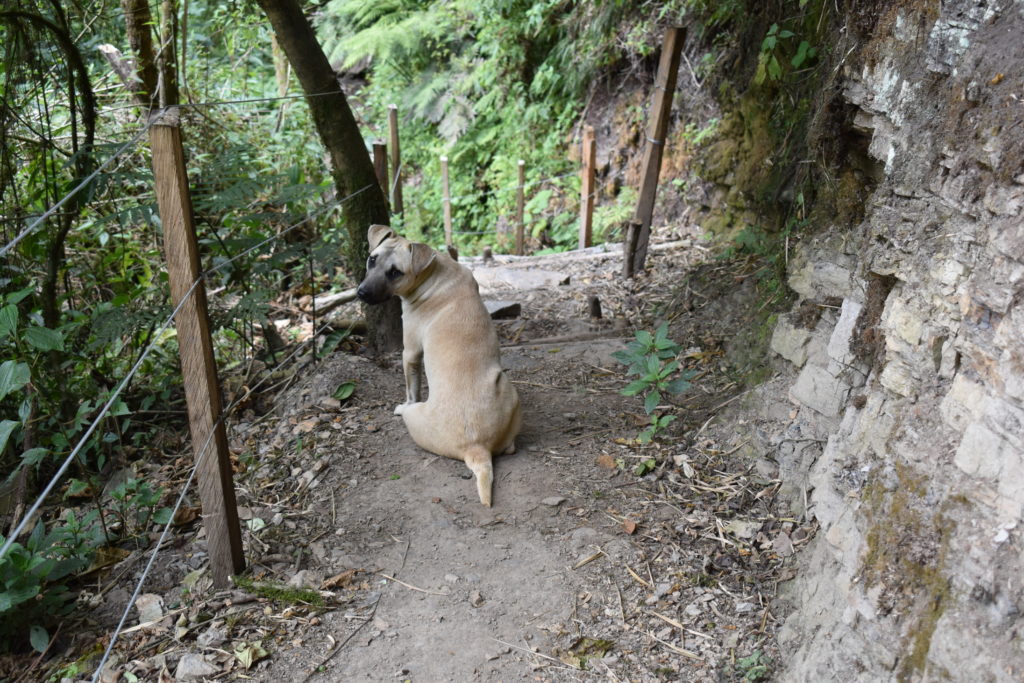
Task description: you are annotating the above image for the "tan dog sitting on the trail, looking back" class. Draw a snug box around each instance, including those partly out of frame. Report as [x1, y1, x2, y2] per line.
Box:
[356, 225, 521, 507]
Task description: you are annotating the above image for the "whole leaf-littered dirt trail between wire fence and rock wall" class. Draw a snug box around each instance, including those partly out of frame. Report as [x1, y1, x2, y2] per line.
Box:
[74, 236, 812, 681]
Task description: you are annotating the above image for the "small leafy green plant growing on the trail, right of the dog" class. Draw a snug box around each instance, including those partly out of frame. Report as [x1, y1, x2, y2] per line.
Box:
[612, 323, 696, 443]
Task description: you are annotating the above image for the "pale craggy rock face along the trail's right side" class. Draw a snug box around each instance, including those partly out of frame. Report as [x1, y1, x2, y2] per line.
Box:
[755, 0, 1024, 681]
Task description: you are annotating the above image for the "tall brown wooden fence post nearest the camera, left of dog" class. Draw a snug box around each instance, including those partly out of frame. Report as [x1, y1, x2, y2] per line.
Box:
[150, 108, 246, 588]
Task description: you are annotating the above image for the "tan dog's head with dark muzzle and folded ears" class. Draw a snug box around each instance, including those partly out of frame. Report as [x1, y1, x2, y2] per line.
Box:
[355, 225, 437, 304]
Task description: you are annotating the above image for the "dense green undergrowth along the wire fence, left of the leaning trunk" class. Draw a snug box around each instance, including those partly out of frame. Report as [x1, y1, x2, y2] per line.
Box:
[0, 0, 341, 647]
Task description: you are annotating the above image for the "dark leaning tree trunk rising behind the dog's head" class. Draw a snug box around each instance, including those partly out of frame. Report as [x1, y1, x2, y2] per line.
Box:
[257, 0, 401, 352]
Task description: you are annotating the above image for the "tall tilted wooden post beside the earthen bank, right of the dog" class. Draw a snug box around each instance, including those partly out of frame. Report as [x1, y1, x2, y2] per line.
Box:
[623, 27, 685, 278]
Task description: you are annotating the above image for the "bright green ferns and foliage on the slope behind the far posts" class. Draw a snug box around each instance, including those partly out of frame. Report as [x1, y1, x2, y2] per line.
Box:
[318, 0, 635, 252]
